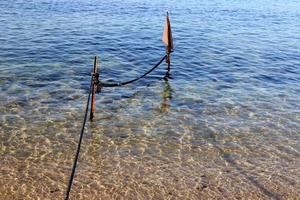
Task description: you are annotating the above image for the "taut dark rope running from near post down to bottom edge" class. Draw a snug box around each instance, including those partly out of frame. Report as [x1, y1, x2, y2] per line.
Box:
[65, 77, 93, 200]
